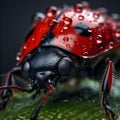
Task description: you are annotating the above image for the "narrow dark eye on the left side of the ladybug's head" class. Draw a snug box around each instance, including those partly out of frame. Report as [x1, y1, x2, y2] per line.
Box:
[22, 62, 30, 78]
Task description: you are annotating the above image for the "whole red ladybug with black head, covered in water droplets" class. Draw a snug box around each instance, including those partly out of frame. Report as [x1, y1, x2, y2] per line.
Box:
[0, 2, 120, 120]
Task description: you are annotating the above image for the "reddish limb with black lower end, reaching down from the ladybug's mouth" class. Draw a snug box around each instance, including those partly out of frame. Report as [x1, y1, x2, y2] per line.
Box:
[30, 85, 55, 120]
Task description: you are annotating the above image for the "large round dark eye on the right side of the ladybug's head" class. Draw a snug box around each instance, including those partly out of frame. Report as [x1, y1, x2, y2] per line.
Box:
[58, 57, 74, 75]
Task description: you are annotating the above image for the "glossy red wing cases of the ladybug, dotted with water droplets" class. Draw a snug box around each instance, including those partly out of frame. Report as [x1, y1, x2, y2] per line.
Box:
[19, 4, 120, 64]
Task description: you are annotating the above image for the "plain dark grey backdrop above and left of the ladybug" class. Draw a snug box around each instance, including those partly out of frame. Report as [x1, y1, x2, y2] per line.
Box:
[0, 0, 120, 73]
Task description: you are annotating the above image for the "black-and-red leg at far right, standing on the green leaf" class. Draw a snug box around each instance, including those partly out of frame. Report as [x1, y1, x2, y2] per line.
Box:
[101, 59, 117, 120]
